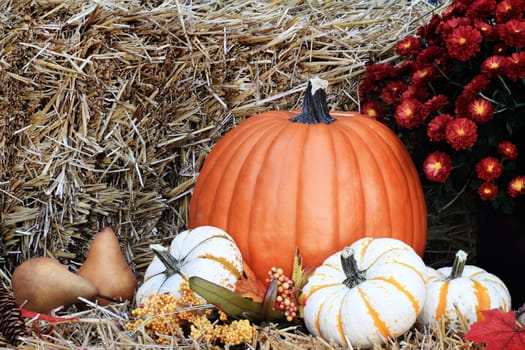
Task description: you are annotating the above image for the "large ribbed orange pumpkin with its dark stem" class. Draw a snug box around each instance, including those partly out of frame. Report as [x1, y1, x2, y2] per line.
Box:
[189, 78, 427, 279]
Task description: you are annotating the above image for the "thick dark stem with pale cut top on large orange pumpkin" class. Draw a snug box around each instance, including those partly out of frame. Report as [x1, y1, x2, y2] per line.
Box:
[290, 78, 335, 124]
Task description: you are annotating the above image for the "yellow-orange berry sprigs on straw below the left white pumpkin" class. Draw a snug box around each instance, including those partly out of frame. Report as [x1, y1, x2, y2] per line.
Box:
[125, 282, 256, 346]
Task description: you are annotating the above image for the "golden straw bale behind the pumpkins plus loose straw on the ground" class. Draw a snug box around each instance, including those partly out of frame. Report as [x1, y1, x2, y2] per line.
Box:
[0, 0, 484, 349]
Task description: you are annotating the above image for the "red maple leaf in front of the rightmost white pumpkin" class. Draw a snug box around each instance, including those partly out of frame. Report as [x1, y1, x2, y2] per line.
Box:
[465, 309, 525, 350]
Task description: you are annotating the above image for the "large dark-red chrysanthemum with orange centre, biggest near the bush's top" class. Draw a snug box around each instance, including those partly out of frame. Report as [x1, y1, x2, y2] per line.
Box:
[445, 25, 483, 61]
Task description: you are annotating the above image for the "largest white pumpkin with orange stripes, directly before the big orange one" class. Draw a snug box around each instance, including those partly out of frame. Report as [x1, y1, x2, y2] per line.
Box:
[302, 238, 426, 348]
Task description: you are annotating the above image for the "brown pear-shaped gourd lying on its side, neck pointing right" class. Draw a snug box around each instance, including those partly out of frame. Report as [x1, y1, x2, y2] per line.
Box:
[11, 257, 98, 314]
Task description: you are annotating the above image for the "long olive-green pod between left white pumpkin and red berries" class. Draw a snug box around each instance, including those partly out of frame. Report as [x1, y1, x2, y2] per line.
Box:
[188, 276, 284, 322]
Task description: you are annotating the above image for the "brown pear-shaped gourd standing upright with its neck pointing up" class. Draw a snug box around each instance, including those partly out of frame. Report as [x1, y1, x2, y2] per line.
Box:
[77, 227, 137, 305]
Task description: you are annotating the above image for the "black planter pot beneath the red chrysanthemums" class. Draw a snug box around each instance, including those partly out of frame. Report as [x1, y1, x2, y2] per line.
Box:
[476, 203, 525, 309]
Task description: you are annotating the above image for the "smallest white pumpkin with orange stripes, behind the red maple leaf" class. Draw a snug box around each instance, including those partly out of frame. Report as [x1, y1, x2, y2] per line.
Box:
[419, 250, 511, 330]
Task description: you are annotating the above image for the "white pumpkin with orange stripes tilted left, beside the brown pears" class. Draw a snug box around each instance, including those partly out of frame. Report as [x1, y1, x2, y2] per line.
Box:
[136, 226, 243, 305]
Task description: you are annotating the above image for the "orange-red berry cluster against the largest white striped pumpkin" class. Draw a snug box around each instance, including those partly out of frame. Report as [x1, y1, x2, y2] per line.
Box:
[266, 267, 297, 322]
